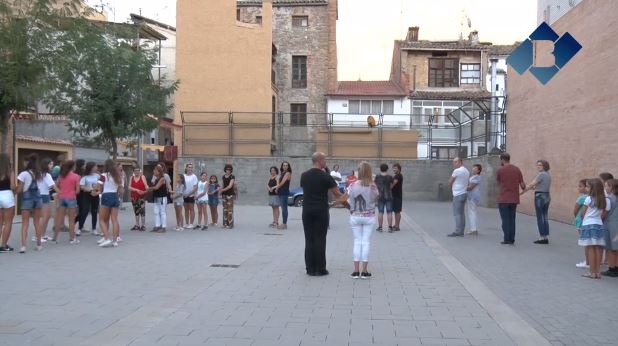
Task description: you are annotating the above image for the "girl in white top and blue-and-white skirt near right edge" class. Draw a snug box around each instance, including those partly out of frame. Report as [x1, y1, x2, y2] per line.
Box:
[577, 179, 611, 279]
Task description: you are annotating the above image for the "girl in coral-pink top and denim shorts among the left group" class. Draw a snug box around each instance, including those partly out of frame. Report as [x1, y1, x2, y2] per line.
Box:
[52, 160, 81, 244]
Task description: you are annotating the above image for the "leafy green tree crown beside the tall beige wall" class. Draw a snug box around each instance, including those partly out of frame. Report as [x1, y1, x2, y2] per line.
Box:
[44, 22, 178, 159]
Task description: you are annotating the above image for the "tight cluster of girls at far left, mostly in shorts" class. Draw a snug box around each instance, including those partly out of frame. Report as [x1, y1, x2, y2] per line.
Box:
[0, 154, 123, 253]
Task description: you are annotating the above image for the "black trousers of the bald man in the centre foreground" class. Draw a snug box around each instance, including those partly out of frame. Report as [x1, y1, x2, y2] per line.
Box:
[303, 208, 329, 273]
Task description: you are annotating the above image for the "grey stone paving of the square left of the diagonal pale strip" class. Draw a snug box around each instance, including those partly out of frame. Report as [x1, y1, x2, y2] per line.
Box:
[0, 206, 528, 346]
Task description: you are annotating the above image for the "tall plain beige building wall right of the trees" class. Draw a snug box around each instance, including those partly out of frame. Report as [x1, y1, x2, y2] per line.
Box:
[175, 0, 273, 155]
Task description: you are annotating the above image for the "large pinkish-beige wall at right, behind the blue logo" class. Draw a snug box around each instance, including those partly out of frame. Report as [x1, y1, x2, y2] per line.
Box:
[507, 0, 618, 221]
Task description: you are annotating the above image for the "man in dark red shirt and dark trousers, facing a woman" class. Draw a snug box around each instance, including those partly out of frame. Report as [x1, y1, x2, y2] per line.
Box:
[496, 153, 526, 245]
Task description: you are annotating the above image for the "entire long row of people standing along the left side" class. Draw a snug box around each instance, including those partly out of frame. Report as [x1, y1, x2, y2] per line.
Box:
[0, 154, 236, 253]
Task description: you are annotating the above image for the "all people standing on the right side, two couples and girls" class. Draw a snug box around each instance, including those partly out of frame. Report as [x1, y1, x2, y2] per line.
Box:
[449, 153, 618, 279]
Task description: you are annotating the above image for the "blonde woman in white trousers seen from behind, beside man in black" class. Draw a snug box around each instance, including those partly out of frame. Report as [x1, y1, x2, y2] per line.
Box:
[347, 161, 380, 279]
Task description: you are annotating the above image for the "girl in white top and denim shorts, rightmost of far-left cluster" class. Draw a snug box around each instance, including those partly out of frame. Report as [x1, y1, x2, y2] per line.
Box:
[96, 160, 124, 247]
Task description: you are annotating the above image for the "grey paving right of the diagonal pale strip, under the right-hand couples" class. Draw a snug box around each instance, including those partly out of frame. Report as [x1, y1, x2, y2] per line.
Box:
[404, 202, 618, 346]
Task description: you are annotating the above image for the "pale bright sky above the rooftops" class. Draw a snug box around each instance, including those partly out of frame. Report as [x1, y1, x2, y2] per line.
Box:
[87, 0, 537, 80]
